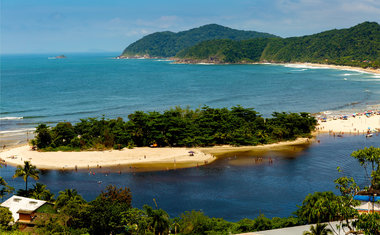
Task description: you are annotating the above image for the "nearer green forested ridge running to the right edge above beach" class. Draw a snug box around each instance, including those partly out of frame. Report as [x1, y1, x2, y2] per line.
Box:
[176, 22, 380, 68]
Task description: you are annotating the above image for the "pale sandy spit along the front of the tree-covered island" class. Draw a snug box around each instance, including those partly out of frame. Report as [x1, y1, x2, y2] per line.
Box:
[0, 138, 311, 170]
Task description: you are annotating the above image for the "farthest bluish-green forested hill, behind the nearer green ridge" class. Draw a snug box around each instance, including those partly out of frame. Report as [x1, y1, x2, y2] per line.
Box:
[122, 24, 276, 57]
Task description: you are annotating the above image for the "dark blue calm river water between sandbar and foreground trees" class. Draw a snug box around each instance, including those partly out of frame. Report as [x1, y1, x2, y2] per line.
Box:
[0, 135, 380, 221]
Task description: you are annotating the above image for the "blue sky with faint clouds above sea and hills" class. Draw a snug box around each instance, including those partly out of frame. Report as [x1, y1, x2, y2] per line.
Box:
[0, 0, 380, 54]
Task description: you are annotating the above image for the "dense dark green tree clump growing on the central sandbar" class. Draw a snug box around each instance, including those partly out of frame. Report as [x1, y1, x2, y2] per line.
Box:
[32, 106, 316, 150]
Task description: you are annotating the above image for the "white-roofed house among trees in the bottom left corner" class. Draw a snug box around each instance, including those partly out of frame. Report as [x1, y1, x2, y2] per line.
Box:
[1, 195, 46, 224]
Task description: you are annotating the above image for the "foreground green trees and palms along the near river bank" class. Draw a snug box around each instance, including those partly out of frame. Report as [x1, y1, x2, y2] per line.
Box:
[0, 147, 380, 235]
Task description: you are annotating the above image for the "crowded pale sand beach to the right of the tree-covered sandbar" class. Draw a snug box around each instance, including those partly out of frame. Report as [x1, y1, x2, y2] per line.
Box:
[317, 115, 380, 134]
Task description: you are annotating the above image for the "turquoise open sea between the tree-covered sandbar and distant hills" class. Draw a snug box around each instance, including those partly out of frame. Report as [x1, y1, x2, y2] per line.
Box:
[0, 53, 380, 142]
